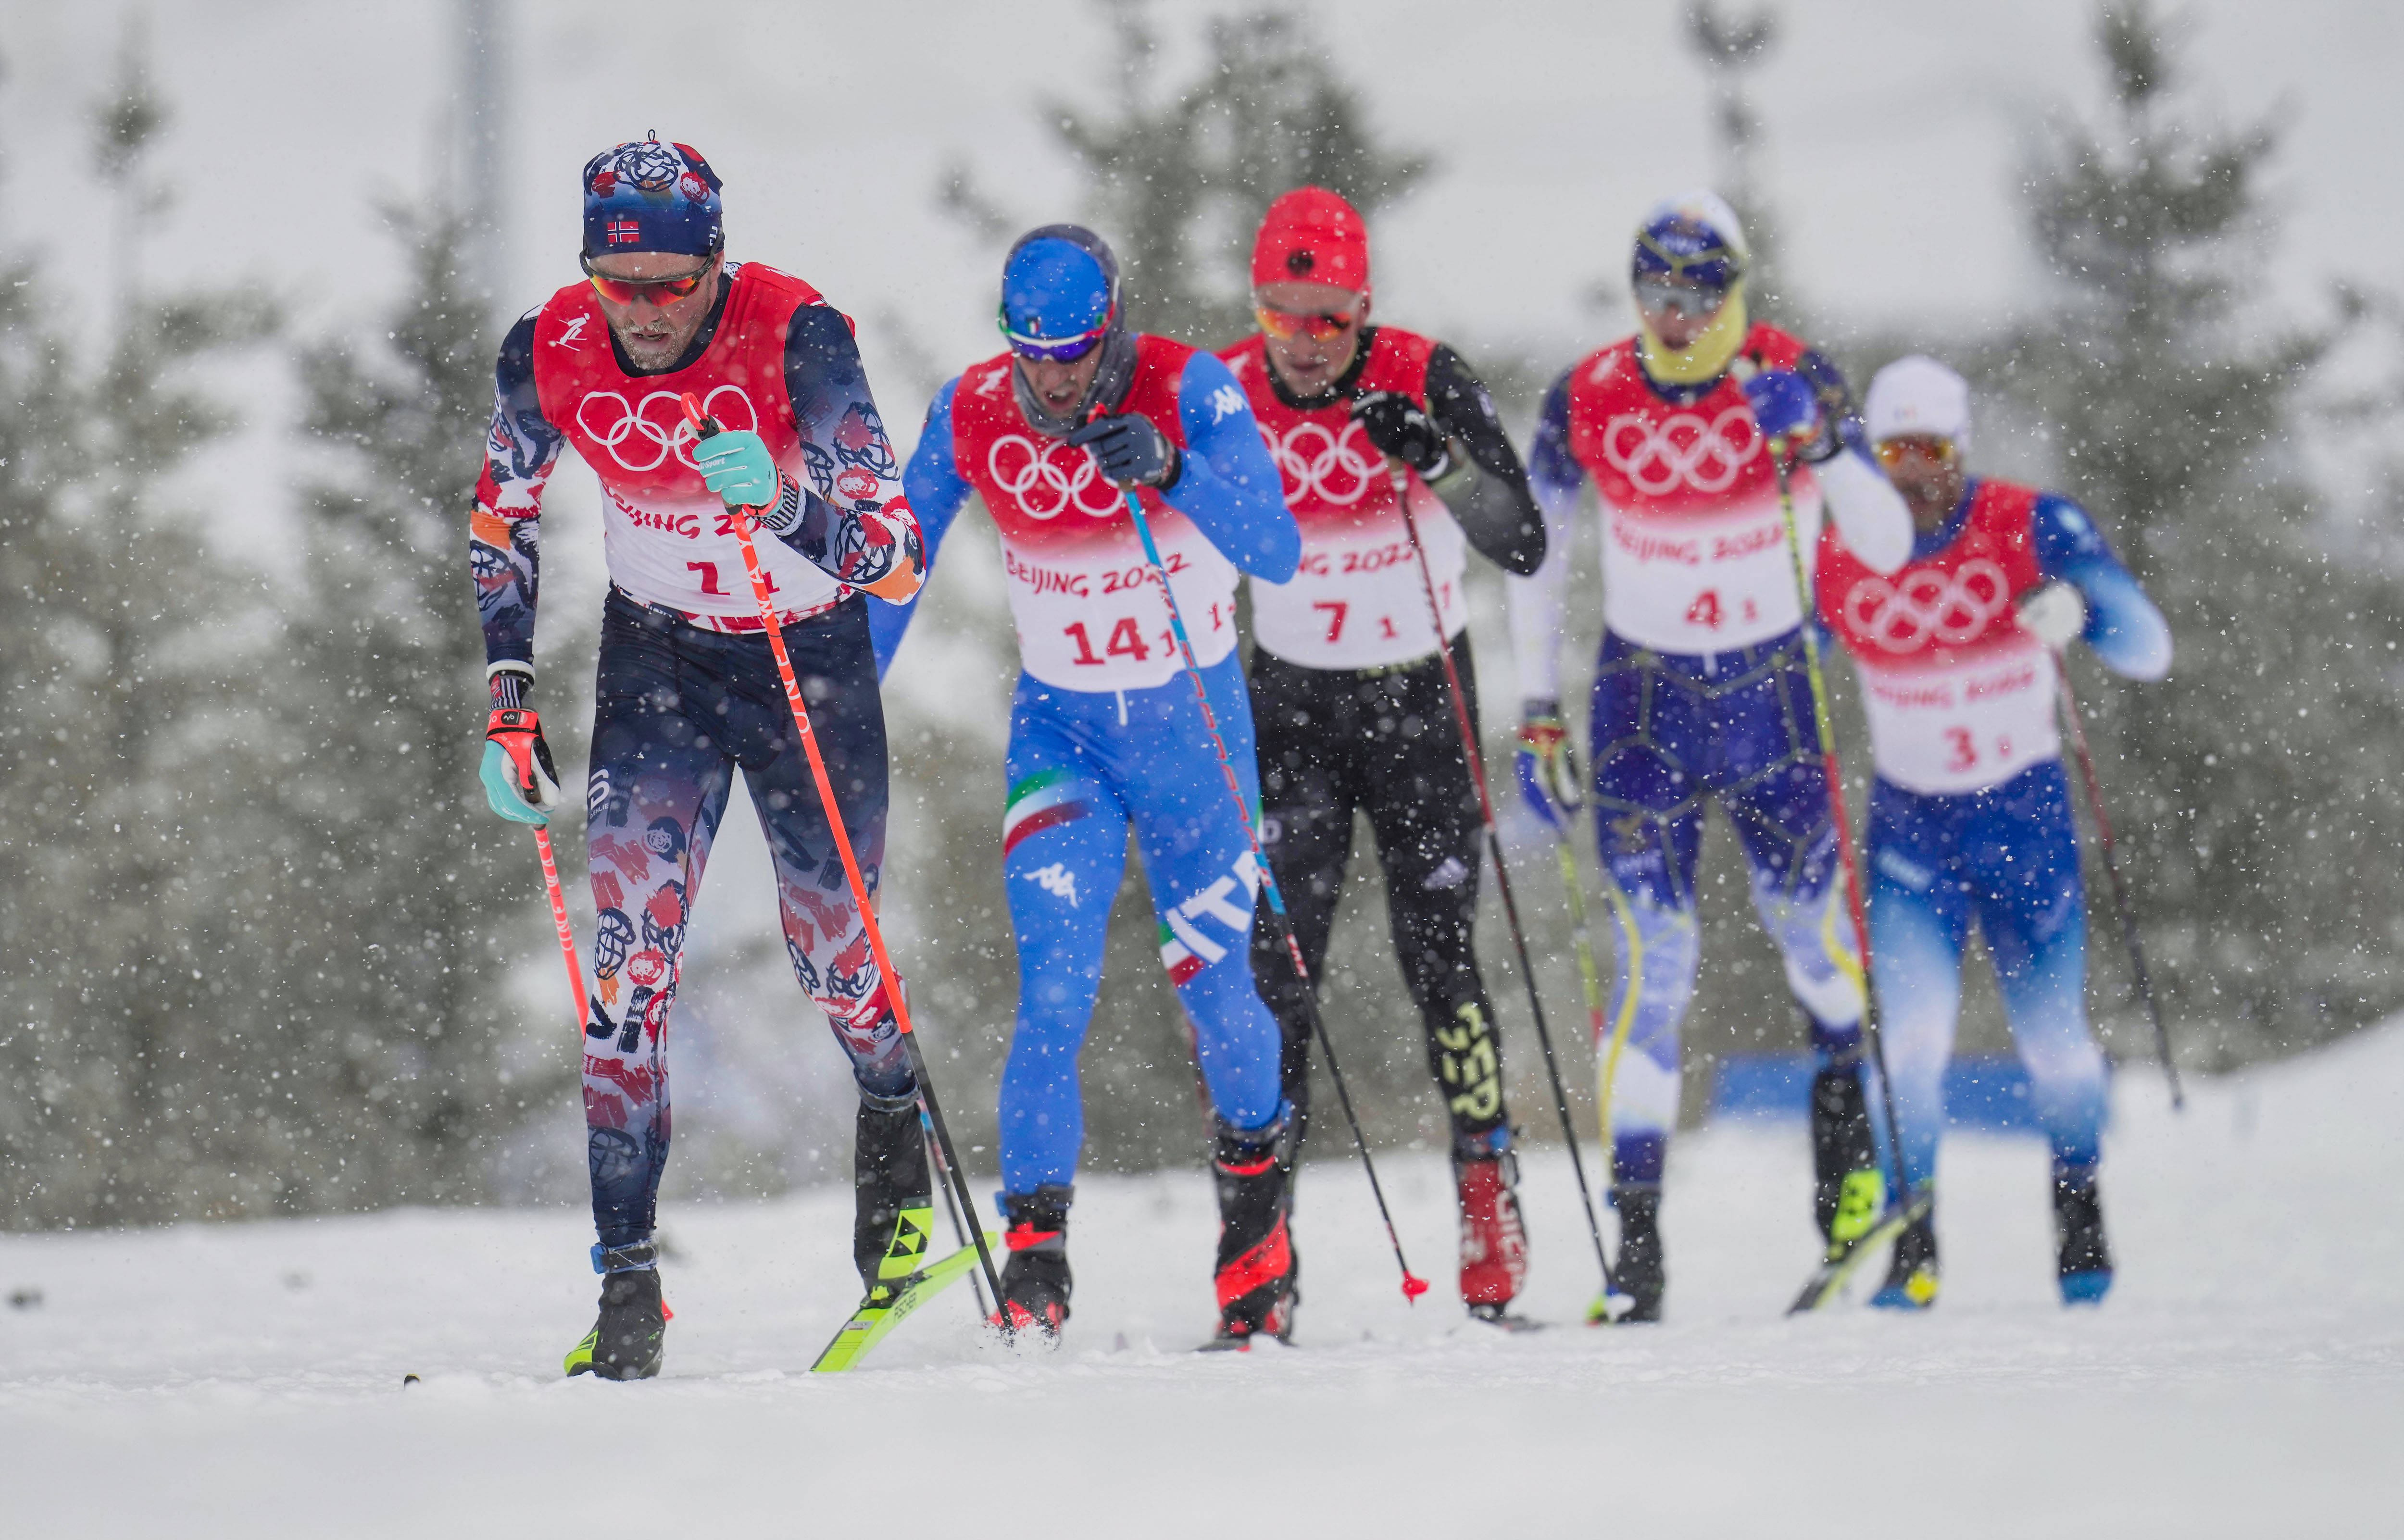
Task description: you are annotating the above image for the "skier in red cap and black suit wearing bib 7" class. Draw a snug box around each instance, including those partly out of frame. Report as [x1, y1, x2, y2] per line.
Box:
[1219, 187, 1543, 1319]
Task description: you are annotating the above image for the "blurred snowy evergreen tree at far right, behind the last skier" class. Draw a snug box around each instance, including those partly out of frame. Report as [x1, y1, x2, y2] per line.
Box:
[1981, 0, 2404, 1064]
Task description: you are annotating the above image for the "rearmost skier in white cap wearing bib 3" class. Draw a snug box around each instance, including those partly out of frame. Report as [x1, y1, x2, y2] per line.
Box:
[1817, 358, 2171, 1309]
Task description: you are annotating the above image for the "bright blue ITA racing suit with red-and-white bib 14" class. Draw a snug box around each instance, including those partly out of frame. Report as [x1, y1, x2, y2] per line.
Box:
[870, 336, 1301, 1194]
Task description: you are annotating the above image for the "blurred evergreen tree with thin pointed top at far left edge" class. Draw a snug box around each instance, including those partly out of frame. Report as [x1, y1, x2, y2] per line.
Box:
[0, 31, 291, 1225]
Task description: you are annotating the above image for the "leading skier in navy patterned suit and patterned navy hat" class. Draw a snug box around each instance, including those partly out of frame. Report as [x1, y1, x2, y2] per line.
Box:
[469, 135, 933, 1379]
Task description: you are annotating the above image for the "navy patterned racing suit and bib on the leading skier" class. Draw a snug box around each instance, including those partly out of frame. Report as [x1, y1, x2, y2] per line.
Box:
[469, 262, 921, 1247]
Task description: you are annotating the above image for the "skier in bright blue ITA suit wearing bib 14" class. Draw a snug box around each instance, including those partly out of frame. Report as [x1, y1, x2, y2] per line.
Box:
[875, 226, 1301, 1345]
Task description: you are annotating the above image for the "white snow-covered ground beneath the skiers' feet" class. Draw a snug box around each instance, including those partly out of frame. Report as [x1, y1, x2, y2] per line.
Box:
[0, 1026, 2404, 1538]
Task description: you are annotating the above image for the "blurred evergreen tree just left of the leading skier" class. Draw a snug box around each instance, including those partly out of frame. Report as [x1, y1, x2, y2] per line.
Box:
[286, 209, 546, 1204]
